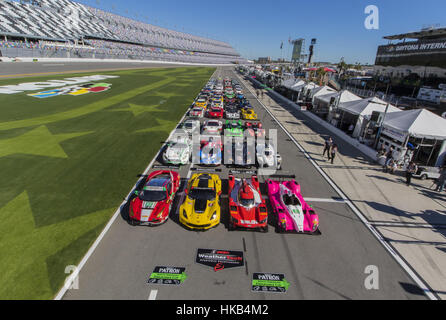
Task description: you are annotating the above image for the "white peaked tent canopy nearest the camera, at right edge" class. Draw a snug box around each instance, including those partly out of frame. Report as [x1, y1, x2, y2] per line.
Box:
[383, 109, 446, 140]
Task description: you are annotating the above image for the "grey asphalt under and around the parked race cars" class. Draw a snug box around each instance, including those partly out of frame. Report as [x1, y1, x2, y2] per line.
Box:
[59, 68, 425, 300]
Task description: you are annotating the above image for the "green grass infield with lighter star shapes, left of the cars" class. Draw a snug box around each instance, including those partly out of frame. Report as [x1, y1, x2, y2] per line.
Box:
[0, 67, 215, 299]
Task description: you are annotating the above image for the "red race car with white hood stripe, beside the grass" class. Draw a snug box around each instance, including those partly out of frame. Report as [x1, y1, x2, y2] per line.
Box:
[129, 170, 180, 226]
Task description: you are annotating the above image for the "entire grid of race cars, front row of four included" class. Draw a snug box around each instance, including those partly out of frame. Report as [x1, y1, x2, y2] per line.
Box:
[129, 78, 320, 234]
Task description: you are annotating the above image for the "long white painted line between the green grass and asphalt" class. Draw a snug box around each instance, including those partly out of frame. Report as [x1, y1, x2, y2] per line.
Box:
[54, 72, 219, 300]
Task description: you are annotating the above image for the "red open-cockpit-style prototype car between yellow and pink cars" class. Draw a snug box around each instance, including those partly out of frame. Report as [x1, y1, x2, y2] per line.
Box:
[229, 175, 268, 232]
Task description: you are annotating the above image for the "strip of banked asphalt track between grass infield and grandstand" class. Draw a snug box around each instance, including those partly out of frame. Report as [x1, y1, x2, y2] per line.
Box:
[0, 61, 208, 79]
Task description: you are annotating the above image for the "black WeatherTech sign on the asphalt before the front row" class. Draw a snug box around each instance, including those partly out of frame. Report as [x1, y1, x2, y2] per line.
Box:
[195, 249, 245, 271]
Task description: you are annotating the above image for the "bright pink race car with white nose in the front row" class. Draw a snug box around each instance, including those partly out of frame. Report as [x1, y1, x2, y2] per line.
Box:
[266, 180, 321, 234]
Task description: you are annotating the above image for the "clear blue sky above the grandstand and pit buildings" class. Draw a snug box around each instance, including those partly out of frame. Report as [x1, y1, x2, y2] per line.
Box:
[78, 0, 446, 63]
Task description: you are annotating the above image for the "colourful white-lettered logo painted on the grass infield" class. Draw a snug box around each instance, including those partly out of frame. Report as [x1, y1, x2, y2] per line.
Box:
[0, 75, 119, 98]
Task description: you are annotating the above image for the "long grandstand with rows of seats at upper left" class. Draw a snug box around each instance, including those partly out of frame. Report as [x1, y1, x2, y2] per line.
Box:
[0, 0, 245, 63]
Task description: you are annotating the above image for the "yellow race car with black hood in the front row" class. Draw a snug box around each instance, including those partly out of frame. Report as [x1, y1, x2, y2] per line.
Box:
[180, 173, 221, 230]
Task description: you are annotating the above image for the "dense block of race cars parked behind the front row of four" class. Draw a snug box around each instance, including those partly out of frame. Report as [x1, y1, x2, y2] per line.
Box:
[163, 78, 282, 170]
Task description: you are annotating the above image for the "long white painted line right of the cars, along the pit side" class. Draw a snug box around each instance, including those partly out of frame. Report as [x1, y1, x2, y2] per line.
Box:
[234, 71, 438, 300]
